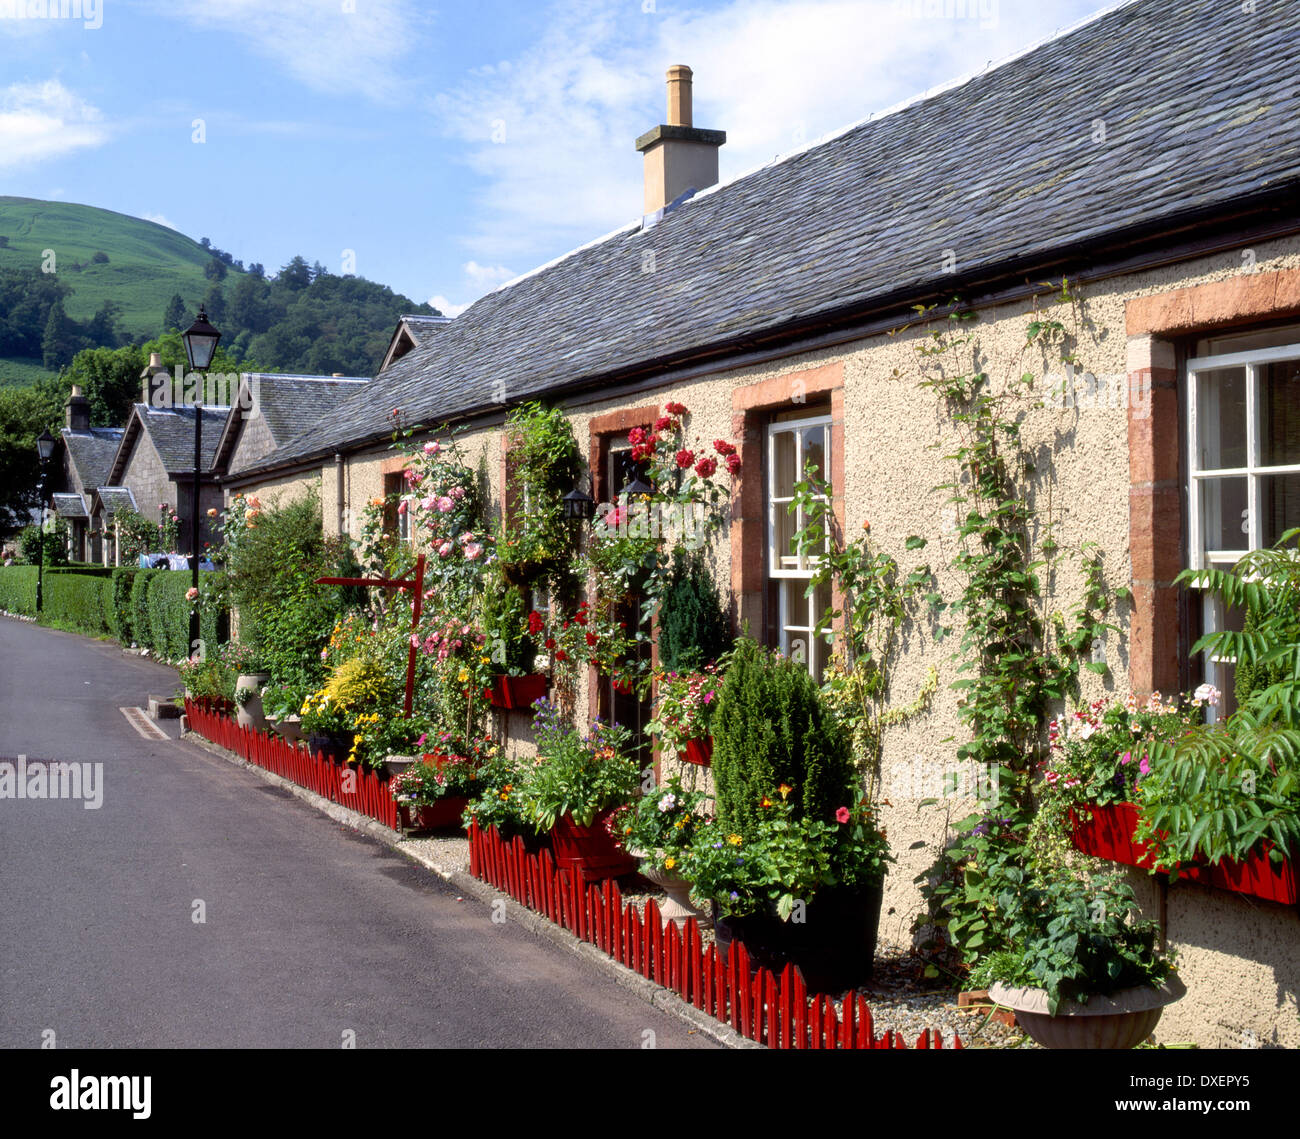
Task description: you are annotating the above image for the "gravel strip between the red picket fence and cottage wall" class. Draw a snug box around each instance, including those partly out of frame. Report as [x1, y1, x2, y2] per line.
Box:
[402, 816, 1037, 1048]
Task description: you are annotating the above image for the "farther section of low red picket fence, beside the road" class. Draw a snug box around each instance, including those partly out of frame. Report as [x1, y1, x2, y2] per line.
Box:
[185, 700, 398, 830]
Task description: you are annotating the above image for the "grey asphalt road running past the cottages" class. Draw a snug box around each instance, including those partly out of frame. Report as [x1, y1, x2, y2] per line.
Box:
[0, 618, 714, 1048]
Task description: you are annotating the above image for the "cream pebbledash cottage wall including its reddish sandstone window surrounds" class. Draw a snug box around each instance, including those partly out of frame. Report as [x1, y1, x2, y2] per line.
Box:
[228, 238, 1300, 1047]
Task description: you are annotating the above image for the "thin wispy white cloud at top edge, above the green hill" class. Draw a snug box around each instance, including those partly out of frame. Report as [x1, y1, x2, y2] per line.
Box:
[153, 0, 429, 101]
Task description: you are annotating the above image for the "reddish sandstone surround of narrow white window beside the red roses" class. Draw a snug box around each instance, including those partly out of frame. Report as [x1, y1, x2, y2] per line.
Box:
[731, 360, 845, 664]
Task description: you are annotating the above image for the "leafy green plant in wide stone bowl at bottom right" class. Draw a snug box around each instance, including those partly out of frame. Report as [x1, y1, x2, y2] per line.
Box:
[971, 869, 1186, 1048]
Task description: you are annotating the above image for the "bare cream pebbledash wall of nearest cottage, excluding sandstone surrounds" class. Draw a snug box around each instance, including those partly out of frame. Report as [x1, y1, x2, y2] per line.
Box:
[231, 239, 1300, 1047]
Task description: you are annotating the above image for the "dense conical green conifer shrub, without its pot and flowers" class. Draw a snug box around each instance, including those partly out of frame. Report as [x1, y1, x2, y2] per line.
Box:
[712, 640, 858, 836]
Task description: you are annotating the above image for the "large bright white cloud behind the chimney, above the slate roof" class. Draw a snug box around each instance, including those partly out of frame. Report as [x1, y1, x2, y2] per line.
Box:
[429, 0, 1097, 263]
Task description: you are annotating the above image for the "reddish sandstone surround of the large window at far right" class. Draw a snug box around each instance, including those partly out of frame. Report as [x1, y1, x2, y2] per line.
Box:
[1125, 269, 1300, 694]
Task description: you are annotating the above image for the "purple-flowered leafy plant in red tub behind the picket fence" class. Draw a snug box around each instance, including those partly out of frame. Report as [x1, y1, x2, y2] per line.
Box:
[523, 701, 641, 880]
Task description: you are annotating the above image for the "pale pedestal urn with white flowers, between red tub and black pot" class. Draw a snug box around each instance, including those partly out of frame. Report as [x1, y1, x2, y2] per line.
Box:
[606, 775, 712, 926]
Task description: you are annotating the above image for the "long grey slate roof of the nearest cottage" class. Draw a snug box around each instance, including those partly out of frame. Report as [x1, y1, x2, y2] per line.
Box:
[245, 0, 1300, 469]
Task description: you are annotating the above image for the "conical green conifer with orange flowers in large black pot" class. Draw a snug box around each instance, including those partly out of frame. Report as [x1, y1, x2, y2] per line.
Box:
[686, 641, 889, 991]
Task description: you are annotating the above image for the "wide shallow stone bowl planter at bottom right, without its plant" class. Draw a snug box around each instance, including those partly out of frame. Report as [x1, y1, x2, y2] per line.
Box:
[988, 973, 1187, 1048]
